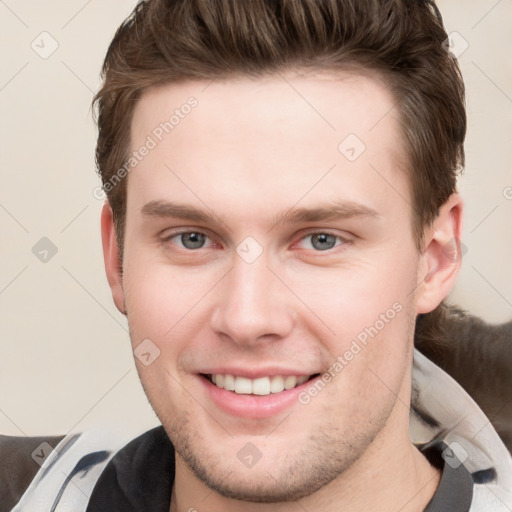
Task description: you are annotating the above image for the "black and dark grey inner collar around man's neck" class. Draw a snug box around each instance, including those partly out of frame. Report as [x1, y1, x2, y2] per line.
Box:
[87, 426, 473, 512]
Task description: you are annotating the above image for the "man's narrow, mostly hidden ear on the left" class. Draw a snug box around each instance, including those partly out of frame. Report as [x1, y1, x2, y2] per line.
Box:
[101, 200, 126, 315]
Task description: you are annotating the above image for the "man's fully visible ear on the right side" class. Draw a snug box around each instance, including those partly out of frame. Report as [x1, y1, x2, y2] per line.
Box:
[416, 193, 464, 314]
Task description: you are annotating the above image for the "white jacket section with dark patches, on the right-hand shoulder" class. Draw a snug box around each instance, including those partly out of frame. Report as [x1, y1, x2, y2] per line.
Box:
[409, 350, 512, 512]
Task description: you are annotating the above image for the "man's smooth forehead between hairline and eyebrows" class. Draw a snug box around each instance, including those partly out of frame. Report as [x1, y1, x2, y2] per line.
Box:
[128, 72, 408, 228]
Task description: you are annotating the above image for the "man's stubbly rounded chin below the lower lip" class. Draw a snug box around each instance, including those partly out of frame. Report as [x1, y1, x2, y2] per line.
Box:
[166, 416, 374, 503]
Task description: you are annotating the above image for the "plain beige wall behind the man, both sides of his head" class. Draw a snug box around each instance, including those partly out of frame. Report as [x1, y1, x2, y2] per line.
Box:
[0, 0, 512, 435]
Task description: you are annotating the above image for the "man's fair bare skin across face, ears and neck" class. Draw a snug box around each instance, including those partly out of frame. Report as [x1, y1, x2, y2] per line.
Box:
[102, 71, 462, 512]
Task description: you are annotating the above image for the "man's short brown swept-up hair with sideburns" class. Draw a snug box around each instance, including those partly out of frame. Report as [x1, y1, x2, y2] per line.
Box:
[94, 0, 466, 348]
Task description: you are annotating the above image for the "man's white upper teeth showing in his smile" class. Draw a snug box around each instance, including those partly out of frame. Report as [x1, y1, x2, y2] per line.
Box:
[212, 374, 309, 395]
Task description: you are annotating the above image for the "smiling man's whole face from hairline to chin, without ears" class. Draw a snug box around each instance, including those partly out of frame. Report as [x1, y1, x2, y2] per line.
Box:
[123, 73, 419, 501]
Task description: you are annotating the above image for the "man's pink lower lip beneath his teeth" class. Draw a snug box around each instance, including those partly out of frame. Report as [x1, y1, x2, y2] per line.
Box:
[198, 375, 318, 419]
